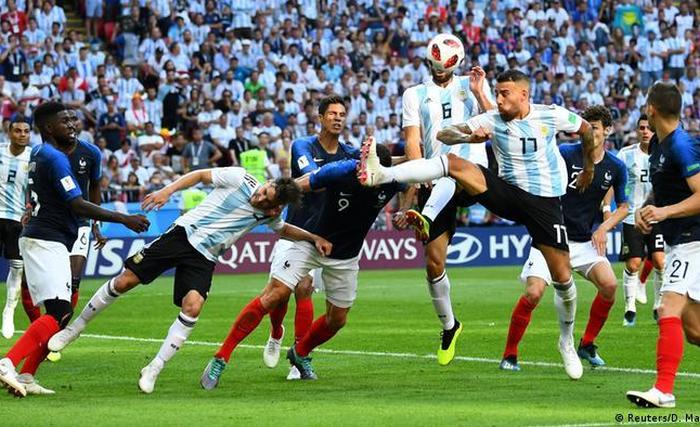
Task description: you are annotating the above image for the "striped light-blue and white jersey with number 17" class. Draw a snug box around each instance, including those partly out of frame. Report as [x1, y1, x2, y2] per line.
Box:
[467, 104, 583, 197]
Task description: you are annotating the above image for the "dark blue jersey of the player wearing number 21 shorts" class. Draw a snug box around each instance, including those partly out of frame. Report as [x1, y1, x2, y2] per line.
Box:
[649, 127, 700, 245]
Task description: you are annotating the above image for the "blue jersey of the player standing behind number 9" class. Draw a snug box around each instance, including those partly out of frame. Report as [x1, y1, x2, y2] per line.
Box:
[286, 136, 359, 231]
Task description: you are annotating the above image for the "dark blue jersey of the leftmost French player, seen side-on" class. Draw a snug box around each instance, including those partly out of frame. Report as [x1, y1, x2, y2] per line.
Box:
[22, 143, 82, 250]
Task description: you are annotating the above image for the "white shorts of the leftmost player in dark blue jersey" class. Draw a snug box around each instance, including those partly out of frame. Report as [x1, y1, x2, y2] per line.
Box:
[19, 237, 71, 305]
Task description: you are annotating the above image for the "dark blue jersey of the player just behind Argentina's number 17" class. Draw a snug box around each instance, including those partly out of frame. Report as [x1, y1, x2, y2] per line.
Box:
[559, 143, 627, 242]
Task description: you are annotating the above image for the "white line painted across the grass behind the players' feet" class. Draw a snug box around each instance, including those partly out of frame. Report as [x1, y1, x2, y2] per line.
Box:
[75, 334, 700, 380]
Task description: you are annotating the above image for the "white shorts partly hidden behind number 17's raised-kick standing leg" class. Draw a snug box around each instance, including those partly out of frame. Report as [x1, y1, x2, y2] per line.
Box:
[520, 241, 610, 285]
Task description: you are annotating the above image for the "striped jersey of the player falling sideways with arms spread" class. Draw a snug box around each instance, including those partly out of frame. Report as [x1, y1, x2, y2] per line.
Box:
[175, 167, 284, 262]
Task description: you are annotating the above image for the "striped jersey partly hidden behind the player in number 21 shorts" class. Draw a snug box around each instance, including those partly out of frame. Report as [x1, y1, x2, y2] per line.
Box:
[617, 144, 651, 225]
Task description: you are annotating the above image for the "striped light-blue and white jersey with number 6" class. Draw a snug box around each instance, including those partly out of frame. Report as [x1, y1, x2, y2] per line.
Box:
[402, 76, 496, 166]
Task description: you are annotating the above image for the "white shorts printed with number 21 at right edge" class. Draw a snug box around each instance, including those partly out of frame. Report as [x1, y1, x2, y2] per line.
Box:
[661, 242, 700, 302]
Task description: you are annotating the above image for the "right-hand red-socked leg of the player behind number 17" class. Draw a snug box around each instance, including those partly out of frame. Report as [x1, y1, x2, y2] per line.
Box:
[574, 258, 617, 367]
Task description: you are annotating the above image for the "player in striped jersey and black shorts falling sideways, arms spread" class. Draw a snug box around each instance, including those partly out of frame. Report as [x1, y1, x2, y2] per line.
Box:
[49, 167, 331, 393]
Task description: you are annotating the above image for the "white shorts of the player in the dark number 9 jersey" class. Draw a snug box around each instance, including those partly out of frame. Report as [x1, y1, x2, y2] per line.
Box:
[270, 242, 360, 308]
